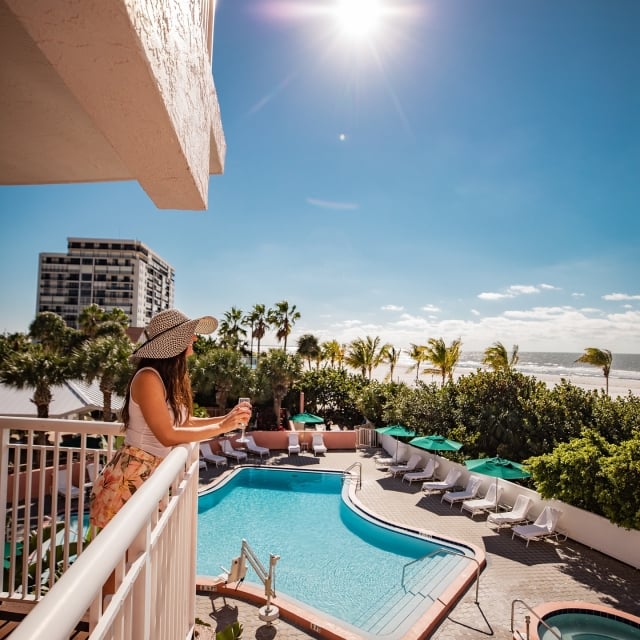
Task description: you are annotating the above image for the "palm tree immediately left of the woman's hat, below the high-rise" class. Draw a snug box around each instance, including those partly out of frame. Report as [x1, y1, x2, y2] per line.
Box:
[73, 332, 132, 422]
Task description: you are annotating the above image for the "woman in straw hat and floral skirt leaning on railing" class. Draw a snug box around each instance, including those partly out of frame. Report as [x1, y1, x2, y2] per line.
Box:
[90, 309, 251, 528]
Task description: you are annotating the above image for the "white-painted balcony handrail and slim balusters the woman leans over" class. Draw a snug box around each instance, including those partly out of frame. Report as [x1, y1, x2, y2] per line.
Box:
[0, 416, 199, 640]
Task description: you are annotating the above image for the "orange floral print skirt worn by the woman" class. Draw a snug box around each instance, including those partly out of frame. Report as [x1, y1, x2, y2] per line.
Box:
[89, 444, 162, 528]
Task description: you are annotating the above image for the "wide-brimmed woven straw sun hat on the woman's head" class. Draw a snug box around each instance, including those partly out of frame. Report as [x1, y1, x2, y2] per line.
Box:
[131, 309, 218, 359]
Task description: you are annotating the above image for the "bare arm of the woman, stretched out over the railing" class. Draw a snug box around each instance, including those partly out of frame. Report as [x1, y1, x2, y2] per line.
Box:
[131, 371, 251, 447]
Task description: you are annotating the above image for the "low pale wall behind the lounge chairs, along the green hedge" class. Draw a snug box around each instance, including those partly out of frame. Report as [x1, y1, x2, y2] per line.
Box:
[380, 435, 640, 569]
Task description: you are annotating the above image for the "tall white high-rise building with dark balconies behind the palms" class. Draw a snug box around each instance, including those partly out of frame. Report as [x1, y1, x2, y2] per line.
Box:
[36, 238, 175, 328]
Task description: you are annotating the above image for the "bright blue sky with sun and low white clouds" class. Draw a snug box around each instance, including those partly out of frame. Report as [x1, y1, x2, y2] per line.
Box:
[0, 0, 640, 353]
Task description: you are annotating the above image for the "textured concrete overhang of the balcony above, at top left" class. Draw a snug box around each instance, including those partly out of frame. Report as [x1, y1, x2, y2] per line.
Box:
[0, 0, 226, 210]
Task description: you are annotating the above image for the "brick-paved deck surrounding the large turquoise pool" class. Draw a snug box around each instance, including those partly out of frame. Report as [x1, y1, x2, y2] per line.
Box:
[196, 449, 640, 640]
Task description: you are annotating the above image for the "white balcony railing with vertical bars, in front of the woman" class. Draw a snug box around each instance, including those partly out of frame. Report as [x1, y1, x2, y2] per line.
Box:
[0, 416, 198, 640]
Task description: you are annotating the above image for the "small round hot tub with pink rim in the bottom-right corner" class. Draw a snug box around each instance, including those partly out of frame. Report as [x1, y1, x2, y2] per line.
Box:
[532, 602, 640, 640]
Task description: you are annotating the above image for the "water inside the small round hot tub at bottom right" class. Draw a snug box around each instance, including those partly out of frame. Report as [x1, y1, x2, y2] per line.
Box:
[538, 611, 640, 640]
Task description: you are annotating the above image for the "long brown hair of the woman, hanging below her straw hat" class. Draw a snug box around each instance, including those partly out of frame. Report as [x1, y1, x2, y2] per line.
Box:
[122, 349, 193, 430]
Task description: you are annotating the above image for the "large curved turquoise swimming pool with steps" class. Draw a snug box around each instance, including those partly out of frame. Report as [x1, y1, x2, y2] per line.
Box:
[197, 467, 475, 638]
